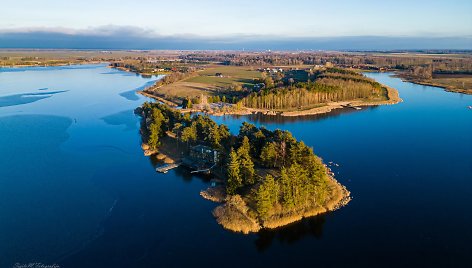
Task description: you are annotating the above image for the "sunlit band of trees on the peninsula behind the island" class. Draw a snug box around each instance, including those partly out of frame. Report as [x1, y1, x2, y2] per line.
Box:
[241, 69, 386, 110]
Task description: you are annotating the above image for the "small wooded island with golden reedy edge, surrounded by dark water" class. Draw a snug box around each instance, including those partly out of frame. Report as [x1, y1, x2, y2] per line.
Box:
[136, 102, 351, 234]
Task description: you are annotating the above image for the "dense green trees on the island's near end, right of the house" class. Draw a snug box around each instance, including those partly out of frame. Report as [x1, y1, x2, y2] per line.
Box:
[226, 123, 328, 221]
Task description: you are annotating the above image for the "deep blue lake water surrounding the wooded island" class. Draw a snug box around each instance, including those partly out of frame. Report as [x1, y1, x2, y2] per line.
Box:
[0, 65, 472, 267]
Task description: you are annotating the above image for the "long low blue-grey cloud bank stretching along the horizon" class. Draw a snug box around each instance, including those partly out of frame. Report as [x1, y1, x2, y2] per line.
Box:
[0, 25, 472, 50]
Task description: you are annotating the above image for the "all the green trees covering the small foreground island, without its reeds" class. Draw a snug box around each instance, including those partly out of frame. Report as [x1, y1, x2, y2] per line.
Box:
[141, 103, 336, 226]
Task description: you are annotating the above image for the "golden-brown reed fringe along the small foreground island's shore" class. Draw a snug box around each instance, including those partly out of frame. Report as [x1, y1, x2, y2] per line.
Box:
[136, 104, 351, 234]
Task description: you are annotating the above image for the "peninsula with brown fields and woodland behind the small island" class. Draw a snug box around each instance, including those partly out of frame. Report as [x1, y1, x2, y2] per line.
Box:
[119, 60, 401, 116]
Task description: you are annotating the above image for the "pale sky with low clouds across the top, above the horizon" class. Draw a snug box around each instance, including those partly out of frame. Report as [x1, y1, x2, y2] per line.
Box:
[0, 0, 472, 48]
